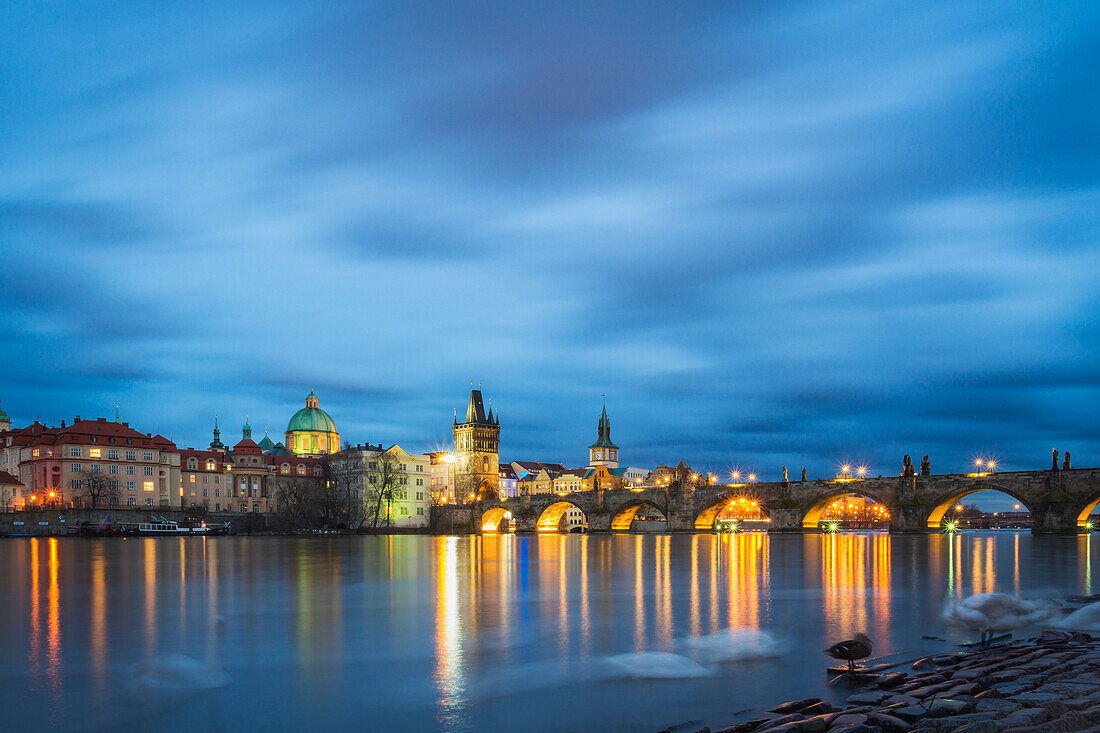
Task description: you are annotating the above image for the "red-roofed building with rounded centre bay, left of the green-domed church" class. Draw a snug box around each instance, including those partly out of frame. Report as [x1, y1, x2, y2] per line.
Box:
[179, 413, 322, 514]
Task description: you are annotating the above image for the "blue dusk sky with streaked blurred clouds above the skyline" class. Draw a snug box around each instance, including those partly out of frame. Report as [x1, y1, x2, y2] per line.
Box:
[0, 0, 1100, 506]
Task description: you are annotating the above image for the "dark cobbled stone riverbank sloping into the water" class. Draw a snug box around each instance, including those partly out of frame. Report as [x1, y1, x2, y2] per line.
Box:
[686, 631, 1100, 733]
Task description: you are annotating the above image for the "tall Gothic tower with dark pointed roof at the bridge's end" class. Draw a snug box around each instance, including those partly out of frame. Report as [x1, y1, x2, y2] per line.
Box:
[453, 390, 501, 503]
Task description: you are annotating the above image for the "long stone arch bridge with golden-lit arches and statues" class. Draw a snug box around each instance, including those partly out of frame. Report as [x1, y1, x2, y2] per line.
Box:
[431, 469, 1100, 534]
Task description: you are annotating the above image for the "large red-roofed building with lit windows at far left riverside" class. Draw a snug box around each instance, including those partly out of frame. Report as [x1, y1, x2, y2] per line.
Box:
[0, 414, 179, 508]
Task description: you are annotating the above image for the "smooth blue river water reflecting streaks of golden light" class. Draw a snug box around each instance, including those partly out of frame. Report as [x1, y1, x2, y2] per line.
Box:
[0, 532, 1097, 732]
